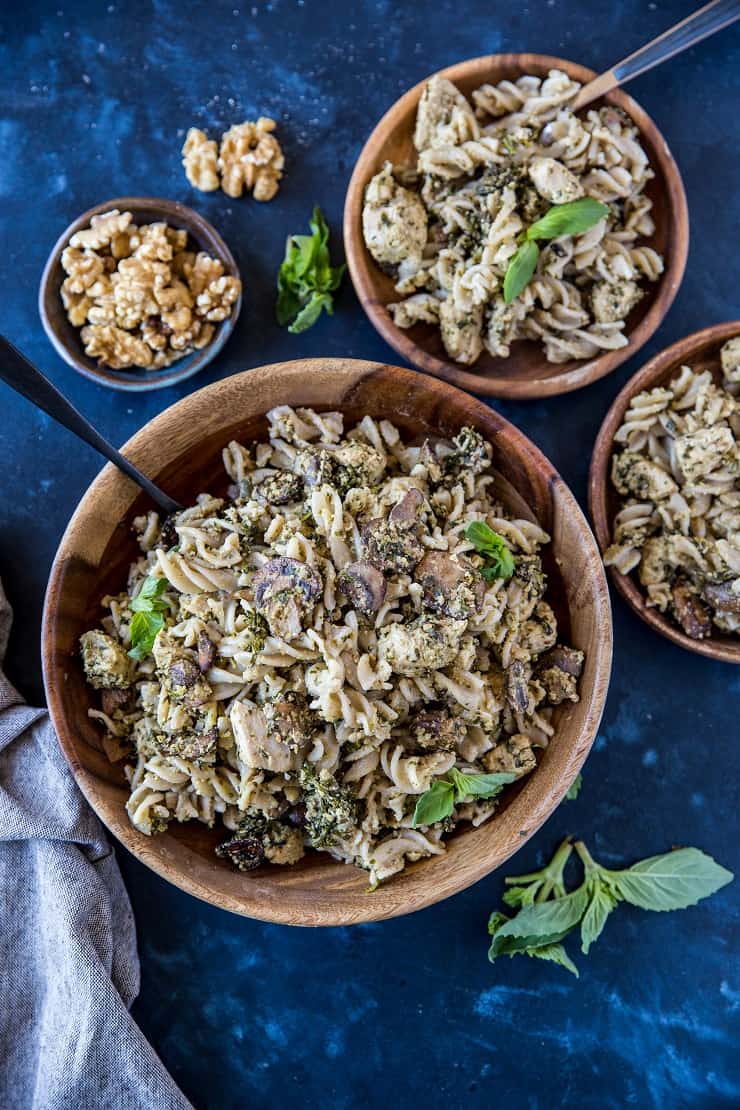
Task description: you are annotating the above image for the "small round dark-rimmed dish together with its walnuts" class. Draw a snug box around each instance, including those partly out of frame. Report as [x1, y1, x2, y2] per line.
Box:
[39, 196, 242, 392]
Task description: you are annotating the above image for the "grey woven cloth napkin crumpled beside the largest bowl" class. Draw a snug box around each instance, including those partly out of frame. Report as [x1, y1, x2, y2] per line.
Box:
[0, 585, 192, 1110]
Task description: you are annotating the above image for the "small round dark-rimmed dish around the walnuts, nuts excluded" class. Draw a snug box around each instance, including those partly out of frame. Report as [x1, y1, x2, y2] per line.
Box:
[39, 196, 242, 393]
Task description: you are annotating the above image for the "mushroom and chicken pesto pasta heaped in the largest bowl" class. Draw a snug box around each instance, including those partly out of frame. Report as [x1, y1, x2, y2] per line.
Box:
[81, 406, 582, 886]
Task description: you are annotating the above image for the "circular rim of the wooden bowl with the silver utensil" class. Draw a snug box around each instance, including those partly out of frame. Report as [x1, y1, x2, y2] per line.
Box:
[344, 52, 689, 401]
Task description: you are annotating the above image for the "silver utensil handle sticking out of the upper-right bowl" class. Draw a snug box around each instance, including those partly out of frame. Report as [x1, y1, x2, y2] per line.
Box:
[571, 0, 740, 111]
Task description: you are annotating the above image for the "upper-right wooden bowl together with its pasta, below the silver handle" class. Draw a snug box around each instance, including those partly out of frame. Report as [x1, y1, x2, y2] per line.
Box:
[344, 54, 688, 397]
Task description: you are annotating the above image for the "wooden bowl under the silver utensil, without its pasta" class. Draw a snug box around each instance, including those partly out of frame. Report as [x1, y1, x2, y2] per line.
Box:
[344, 54, 689, 398]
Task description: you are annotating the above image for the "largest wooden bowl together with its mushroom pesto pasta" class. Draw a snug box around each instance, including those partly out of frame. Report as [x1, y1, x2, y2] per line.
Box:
[44, 360, 611, 925]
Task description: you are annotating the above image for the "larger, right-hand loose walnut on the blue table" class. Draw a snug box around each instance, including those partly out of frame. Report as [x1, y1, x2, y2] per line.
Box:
[219, 115, 285, 201]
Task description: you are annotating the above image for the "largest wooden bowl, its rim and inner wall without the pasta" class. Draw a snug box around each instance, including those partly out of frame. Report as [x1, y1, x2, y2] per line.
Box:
[42, 359, 611, 925]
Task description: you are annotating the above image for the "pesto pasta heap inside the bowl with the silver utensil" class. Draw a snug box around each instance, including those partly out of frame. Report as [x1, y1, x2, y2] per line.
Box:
[363, 70, 663, 365]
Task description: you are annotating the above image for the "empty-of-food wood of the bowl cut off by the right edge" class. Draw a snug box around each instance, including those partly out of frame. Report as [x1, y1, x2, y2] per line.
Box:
[588, 320, 740, 663]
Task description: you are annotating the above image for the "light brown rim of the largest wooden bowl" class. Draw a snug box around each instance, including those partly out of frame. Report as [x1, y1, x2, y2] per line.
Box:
[41, 359, 612, 926]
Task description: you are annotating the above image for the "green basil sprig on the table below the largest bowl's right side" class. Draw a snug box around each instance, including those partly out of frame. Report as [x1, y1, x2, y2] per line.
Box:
[488, 839, 733, 976]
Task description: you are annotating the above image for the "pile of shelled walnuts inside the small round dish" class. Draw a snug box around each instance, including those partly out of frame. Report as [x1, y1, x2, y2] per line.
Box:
[60, 211, 242, 370]
